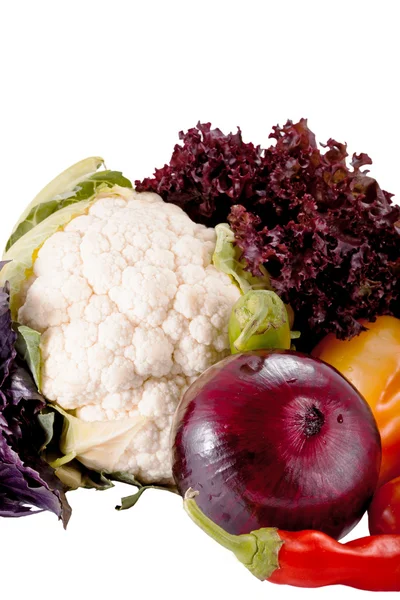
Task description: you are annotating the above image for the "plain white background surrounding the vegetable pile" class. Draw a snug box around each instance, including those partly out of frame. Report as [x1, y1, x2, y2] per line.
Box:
[0, 0, 400, 600]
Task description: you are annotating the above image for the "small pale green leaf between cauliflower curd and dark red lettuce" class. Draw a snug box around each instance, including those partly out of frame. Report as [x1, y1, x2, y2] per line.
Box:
[213, 223, 272, 294]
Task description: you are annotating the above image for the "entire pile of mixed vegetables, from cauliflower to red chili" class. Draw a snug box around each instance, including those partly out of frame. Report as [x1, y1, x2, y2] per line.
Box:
[0, 119, 400, 591]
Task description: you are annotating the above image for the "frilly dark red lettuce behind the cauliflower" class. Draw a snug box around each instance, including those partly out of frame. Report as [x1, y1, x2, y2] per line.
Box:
[136, 119, 400, 350]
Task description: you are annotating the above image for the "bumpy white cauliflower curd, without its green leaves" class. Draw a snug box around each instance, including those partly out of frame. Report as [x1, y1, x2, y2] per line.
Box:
[19, 190, 239, 483]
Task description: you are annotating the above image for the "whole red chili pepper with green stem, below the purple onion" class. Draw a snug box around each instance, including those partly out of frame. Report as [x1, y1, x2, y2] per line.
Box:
[184, 490, 400, 592]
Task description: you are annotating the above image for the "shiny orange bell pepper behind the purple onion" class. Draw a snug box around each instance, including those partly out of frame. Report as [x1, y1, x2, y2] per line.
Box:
[312, 316, 400, 484]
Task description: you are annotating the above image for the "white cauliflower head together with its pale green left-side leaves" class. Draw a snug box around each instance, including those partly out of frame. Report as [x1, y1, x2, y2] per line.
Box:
[3, 158, 240, 485]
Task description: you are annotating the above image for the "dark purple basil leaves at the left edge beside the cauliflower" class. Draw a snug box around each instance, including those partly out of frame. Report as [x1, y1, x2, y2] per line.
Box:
[0, 264, 71, 526]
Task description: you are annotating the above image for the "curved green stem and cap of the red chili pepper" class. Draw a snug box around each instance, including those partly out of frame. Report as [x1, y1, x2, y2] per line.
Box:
[183, 488, 283, 580]
